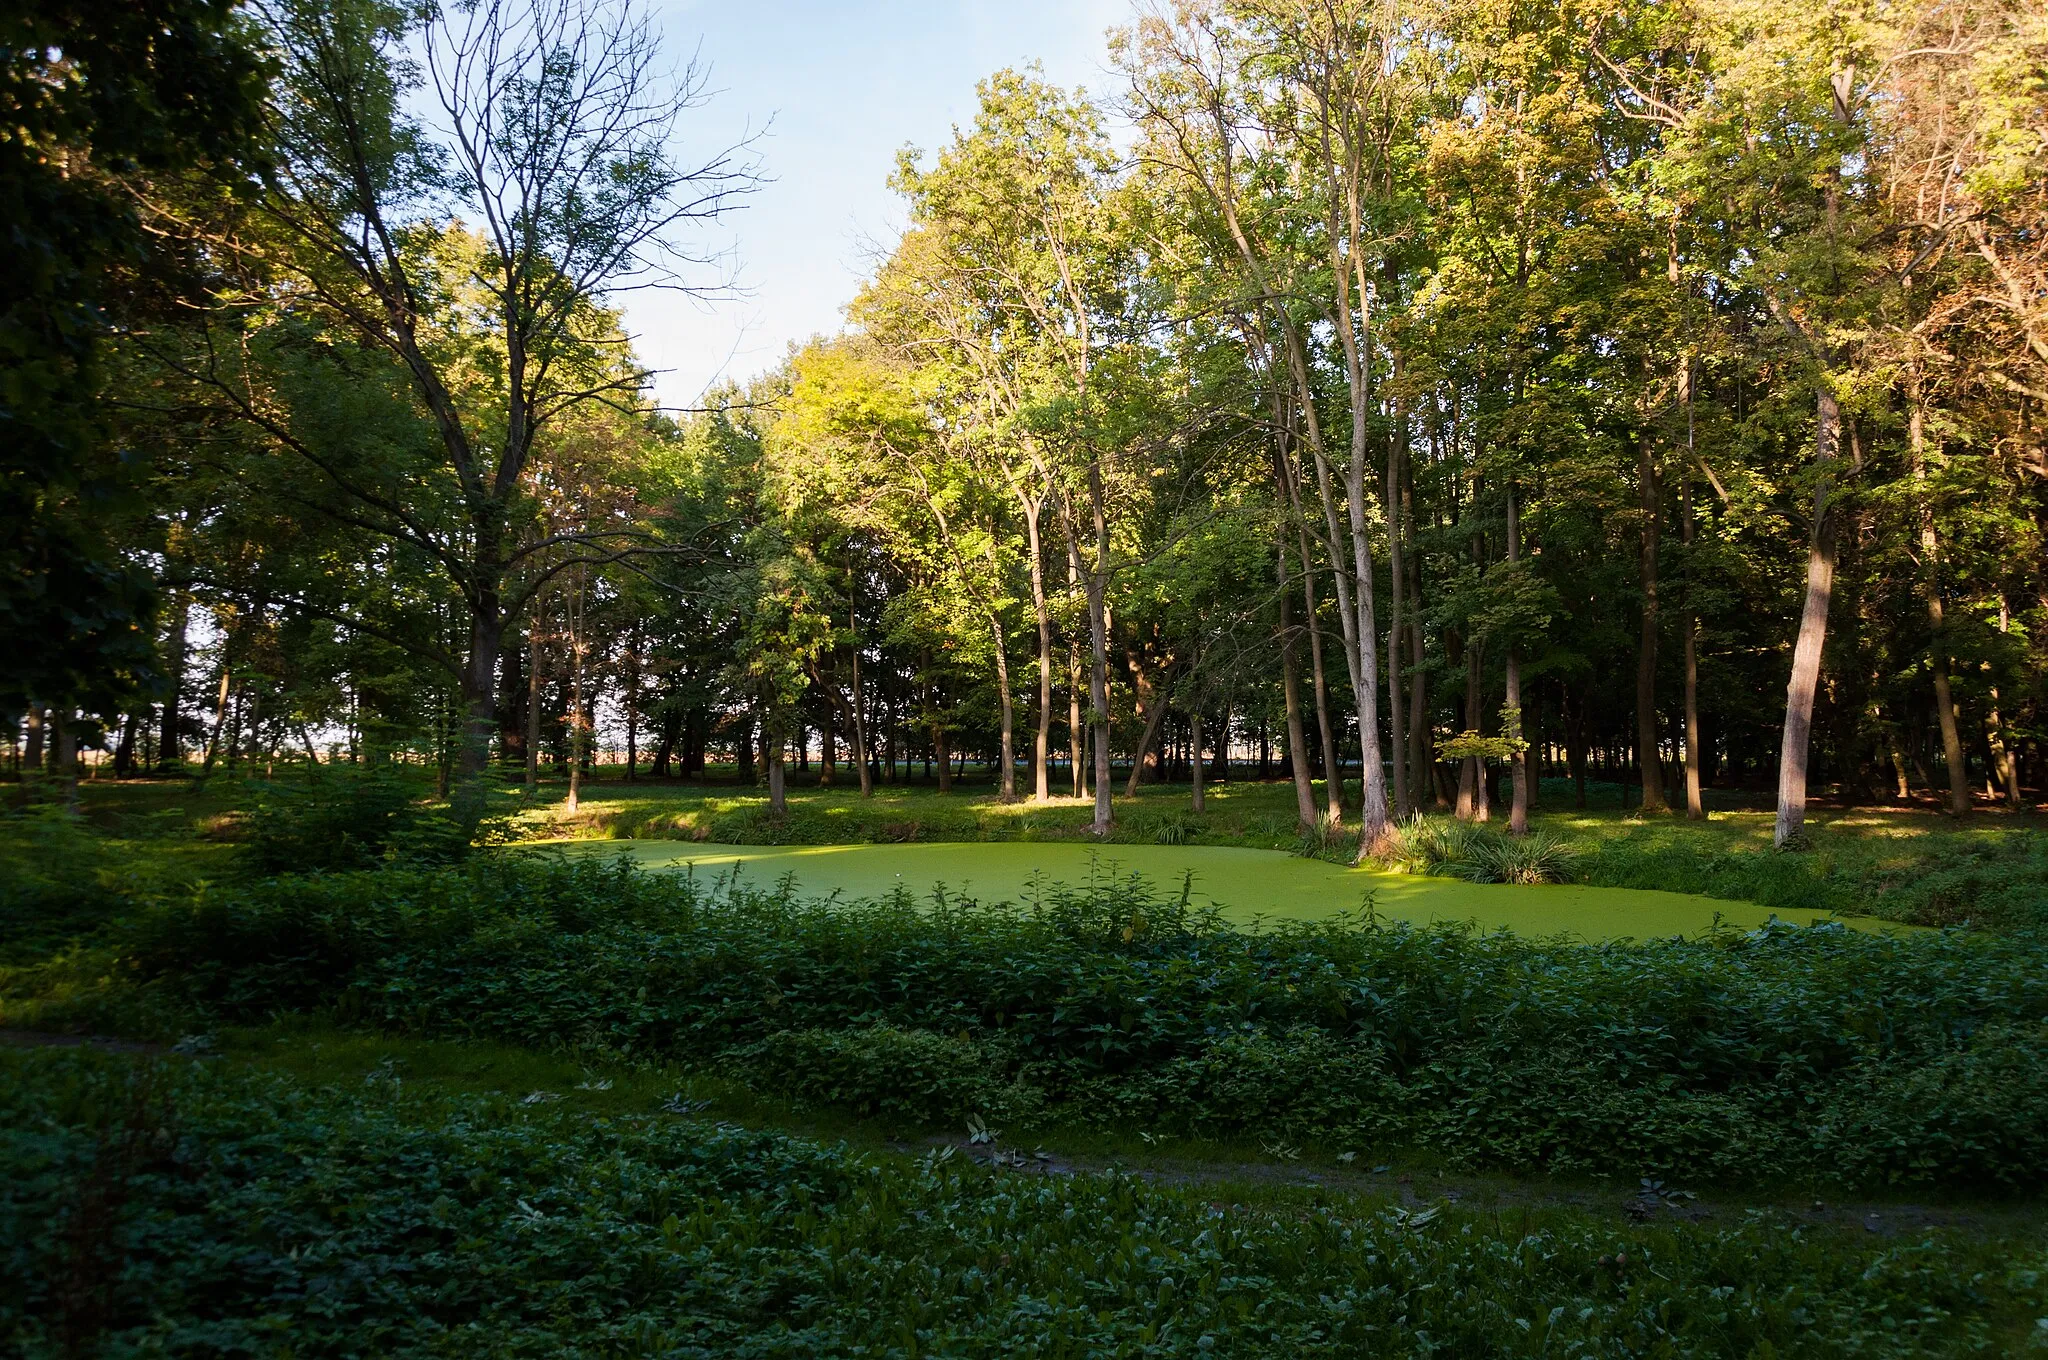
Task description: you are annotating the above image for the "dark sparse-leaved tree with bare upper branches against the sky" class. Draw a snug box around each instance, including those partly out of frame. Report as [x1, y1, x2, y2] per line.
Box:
[218, 0, 752, 776]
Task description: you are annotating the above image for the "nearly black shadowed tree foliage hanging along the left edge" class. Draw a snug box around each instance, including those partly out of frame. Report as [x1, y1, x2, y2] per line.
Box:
[0, 0, 262, 746]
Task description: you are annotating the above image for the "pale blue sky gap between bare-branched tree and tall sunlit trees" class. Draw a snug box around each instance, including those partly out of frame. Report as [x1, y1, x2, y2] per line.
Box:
[621, 0, 1130, 406]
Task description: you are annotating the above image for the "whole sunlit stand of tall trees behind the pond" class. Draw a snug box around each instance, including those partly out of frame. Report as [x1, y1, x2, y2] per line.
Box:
[6, 4, 2048, 850]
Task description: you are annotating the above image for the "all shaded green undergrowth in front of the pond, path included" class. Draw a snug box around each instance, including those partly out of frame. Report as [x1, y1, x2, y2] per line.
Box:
[0, 798, 2048, 1360]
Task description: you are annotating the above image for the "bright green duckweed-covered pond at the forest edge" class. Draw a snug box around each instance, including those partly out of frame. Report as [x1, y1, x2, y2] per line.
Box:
[539, 840, 1903, 942]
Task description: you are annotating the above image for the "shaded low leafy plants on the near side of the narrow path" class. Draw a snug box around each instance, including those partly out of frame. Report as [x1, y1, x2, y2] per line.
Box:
[0, 1053, 2048, 1360]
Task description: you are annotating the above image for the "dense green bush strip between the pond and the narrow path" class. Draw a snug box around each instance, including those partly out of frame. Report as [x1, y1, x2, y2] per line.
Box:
[83, 858, 2048, 1186]
